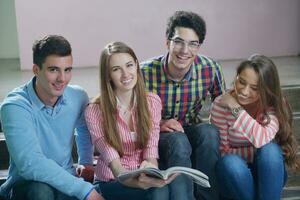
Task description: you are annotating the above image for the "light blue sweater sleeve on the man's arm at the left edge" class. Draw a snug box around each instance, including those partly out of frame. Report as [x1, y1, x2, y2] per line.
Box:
[1, 103, 93, 199]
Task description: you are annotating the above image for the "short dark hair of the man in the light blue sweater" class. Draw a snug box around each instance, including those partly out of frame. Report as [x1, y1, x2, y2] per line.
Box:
[32, 35, 72, 69]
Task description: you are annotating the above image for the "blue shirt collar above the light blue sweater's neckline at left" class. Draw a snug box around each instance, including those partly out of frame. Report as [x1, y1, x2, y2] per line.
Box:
[27, 76, 67, 109]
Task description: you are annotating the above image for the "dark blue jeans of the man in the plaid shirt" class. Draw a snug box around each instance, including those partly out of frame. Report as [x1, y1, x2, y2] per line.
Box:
[159, 123, 220, 200]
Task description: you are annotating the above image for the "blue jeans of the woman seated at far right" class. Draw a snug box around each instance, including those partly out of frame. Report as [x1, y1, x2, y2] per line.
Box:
[216, 143, 287, 200]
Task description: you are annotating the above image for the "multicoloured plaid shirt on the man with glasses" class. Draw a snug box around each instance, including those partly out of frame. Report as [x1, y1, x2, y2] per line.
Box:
[141, 55, 225, 125]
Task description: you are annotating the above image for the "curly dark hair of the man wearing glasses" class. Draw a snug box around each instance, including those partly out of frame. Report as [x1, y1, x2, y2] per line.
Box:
[166, 11, 206, 44]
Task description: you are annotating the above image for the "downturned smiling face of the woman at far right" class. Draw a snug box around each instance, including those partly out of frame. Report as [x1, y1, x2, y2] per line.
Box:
[234, 67, 259, 105]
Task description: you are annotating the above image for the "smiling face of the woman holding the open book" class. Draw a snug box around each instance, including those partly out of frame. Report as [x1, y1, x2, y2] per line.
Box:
[109, 53, 137, 93]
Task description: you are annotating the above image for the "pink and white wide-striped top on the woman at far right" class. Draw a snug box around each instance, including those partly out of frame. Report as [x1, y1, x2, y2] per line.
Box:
[210, 97, 279, 162]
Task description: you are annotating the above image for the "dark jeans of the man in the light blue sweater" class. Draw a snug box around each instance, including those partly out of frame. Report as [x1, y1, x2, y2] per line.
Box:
[10, 181, 78, 200]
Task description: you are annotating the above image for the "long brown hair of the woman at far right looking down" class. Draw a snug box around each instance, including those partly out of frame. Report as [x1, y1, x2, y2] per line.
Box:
[237, 55, 300, 169]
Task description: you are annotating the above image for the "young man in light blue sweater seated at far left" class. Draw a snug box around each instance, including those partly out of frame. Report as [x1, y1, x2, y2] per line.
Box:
[0, 35, 103, 200]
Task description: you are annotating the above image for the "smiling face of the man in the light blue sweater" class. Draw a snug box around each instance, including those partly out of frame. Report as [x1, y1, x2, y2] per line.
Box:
[33, 55, 73, 106]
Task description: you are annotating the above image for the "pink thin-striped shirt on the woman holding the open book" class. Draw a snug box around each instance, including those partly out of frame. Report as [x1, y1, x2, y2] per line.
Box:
[85, 93, 162, 181]
